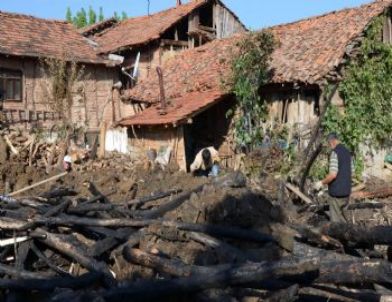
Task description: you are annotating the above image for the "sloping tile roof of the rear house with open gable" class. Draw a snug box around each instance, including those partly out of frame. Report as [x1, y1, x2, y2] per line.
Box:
[95, 0, 243, 53]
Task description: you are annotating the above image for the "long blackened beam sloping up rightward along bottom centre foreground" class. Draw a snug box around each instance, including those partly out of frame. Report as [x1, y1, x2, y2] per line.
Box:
[102, 251, 319, 301]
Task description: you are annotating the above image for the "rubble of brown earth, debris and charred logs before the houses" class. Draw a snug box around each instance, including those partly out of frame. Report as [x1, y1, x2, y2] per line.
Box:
[0, 133, 392, 301]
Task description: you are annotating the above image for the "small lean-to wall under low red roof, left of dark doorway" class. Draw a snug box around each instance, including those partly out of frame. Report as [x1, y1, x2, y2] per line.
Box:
[128, 126, 186, 171]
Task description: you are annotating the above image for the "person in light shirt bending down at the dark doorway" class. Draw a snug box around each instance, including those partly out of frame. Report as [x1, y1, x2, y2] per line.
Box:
[191, 147, 220, 177]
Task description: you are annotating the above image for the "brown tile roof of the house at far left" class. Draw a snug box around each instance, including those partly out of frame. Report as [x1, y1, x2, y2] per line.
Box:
[0, 11, 105, 63]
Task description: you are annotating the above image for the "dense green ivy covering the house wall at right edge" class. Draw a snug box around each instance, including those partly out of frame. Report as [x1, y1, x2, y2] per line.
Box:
[324, 16, 392, 151]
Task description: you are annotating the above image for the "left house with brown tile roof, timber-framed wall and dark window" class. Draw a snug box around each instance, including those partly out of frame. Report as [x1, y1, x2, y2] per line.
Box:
[0, 12, 119, 131]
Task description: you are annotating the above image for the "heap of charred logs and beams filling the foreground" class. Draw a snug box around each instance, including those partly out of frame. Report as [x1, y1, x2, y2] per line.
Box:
[0, 173, 392, 301]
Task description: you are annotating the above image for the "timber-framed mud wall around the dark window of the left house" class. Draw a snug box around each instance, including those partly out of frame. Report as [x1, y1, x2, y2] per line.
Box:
[0, 56, 120, 130]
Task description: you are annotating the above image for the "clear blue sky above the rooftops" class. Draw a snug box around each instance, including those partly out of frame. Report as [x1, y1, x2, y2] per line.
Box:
[0, 0, 370, 29]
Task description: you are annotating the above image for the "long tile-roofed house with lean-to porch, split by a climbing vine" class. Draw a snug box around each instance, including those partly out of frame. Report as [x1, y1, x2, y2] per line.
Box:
[116, 1, 391, 169]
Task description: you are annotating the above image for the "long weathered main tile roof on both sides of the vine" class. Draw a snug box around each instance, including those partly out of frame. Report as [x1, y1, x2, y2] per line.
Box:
[121, 1, 391, 124]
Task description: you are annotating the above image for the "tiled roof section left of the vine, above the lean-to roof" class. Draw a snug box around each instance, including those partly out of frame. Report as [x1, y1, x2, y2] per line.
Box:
[127, 35, 239, 103]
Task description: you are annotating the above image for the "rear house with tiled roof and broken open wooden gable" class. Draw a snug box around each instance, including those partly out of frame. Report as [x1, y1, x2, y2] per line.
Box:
[82, 0, 246, 88]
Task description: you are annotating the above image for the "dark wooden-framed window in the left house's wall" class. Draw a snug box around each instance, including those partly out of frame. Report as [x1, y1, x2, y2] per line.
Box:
[0, 68, 23, 102]
